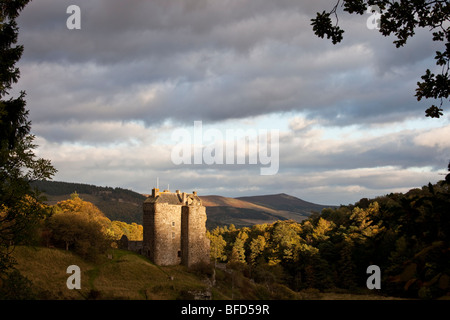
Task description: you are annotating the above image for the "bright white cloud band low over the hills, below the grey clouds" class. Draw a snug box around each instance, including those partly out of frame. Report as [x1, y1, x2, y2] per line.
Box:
[31, 116, 446, 204]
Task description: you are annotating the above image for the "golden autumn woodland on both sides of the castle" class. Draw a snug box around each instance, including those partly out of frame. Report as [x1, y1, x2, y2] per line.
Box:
[0, 181, 450, 299]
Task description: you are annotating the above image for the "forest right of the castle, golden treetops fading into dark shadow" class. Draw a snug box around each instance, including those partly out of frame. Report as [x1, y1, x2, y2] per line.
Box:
[208, 181, 450, 299]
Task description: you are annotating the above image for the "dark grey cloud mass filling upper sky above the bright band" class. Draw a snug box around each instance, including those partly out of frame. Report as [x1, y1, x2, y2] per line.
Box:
[15, 0, 442, 130]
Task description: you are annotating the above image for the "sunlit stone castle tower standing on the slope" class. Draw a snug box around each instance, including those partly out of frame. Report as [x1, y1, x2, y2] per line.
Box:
[142, 188, 210, 267]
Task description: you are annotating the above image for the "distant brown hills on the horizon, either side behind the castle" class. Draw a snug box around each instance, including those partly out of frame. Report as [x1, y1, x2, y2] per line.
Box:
[33, 181, 334, 229]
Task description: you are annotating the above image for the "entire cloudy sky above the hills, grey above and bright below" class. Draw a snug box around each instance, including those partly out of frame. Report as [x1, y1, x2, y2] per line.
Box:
[12, 0, 450, 205]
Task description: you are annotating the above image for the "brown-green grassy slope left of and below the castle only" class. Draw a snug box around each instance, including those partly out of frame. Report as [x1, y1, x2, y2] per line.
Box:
[14, 246, 206, 300]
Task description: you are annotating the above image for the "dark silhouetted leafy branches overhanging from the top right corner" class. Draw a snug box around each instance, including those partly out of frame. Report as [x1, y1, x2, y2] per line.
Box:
[311, 0, 450, 118]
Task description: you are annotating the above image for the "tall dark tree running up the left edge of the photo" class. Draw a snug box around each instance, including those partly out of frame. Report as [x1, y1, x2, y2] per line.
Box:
[0, 0, 56, 272]
